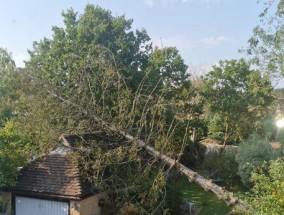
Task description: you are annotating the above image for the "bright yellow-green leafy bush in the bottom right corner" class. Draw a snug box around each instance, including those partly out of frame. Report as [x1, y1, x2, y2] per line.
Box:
[236, 159, 284, 215]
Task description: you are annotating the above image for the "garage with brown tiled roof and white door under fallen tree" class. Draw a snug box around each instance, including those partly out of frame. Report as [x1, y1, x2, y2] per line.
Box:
[2, 132, 115, 215]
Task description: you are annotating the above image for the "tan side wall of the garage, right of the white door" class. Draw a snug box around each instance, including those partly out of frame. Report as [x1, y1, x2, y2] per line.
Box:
[70, 193, 107, 215]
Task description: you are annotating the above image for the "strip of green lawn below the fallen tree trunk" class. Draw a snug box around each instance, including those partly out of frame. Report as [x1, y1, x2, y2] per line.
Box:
[176, 176, 231, 215]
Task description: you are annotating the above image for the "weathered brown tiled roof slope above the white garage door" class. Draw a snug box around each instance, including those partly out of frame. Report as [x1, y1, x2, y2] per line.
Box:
[11, 152, 94, 199]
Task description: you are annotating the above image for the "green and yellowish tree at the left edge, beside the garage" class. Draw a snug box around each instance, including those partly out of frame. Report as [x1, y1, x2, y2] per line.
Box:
[0, 48, 31, 186]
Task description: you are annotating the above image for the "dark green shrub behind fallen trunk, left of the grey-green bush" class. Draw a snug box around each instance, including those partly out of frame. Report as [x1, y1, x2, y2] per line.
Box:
[202, 147, 240, 188]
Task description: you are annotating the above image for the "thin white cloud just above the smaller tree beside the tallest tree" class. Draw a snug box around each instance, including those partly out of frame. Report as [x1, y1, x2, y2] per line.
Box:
[153, 36, 194, 50]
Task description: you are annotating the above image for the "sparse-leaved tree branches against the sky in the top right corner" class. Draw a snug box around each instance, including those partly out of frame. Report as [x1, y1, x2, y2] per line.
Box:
[246, 0, 284, 78]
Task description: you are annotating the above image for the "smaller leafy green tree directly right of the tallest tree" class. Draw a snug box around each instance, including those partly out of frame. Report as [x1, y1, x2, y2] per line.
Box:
[147, 47, 202, 147]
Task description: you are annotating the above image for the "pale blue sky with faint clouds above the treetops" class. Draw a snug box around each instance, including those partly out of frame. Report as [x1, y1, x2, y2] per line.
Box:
[0, 0, 261, 66]
